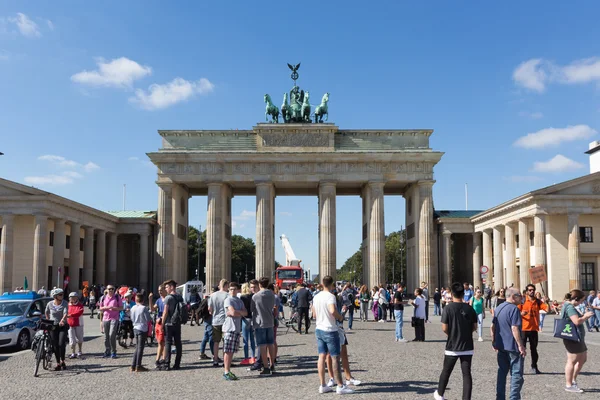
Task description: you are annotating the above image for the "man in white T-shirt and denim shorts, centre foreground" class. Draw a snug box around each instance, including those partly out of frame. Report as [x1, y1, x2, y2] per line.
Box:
[312, 275, 354, 394]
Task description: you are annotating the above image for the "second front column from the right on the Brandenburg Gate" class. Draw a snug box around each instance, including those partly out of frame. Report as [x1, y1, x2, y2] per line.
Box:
[368, 182, 386, 287]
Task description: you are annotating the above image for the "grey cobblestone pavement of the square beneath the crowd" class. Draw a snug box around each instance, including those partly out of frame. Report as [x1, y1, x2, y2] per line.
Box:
[0, 307, 600, 400]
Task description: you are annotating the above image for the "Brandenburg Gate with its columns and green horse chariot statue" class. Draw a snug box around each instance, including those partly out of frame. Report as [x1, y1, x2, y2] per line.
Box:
[148, 66, 443, 288]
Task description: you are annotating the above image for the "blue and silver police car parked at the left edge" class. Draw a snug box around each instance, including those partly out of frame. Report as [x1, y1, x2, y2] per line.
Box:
[0, 292, 52, 350]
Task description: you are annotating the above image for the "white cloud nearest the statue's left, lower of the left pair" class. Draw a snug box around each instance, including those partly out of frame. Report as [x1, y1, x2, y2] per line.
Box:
[129, 78, 214, 110]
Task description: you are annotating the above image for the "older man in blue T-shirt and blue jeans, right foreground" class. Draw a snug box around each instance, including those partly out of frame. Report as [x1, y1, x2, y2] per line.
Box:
[490, 288, 527, 400]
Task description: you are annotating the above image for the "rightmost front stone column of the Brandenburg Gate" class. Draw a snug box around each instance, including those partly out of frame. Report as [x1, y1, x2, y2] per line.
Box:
[420, 181, 439, 290]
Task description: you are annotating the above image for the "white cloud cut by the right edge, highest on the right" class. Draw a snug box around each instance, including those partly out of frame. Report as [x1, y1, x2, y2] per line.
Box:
[513, 57, 600, 93]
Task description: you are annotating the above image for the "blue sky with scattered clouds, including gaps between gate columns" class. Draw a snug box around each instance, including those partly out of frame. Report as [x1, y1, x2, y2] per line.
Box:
[0, 1, 600, 271]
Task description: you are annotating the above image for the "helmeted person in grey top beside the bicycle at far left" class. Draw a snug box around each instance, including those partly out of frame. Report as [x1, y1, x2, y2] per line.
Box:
[45, 289, 69, 371]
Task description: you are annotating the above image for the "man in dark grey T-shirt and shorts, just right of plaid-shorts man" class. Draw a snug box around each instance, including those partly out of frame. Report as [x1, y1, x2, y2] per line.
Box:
[251, 278, 277, 376]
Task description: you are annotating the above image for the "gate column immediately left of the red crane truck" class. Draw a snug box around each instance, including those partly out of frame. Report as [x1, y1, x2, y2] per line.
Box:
[256, 182, 275, 280]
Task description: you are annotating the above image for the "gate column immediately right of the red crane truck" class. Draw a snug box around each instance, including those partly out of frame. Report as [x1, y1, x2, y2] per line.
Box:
[319, 182, 336, 281]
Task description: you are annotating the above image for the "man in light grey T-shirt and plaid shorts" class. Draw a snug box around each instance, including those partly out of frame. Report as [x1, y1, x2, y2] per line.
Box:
[223, 282, 248, 381]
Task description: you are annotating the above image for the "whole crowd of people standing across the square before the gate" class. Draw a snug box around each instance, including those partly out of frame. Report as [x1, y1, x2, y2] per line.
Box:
[34, 276, 600, 399]
